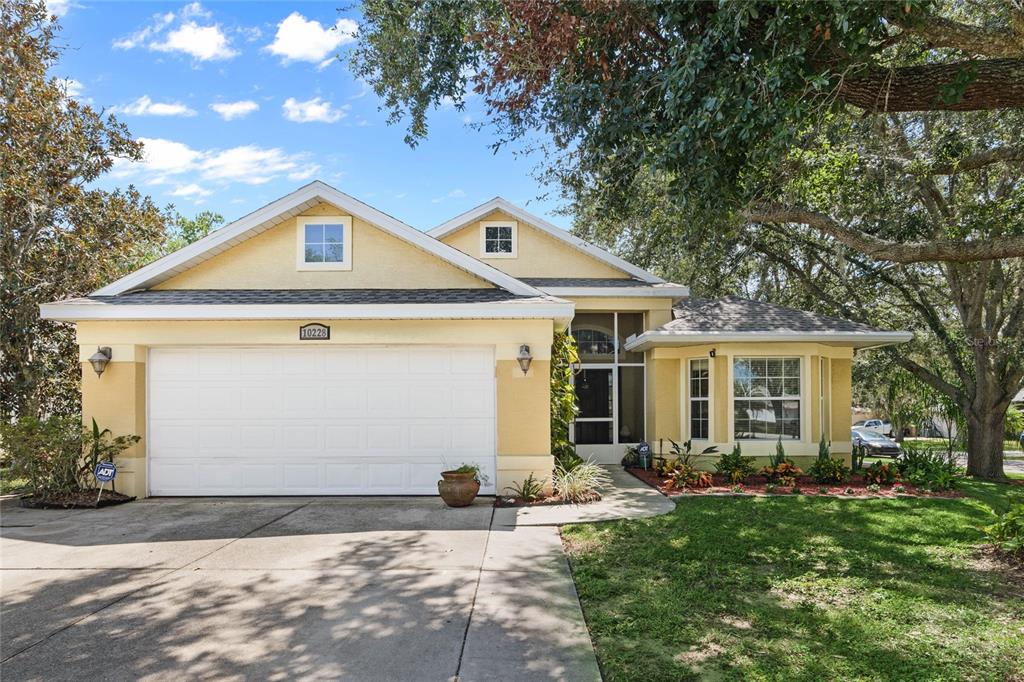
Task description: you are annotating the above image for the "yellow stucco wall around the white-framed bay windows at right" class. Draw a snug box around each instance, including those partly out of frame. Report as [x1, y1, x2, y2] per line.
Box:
[647, 343, 853, 468]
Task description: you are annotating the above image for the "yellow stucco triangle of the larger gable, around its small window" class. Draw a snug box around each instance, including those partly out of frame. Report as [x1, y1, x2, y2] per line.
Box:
[155, 204, 493, 289]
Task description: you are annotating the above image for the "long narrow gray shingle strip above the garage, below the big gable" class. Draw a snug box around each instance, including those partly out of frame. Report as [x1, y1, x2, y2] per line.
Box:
[63, 289, 536, 305]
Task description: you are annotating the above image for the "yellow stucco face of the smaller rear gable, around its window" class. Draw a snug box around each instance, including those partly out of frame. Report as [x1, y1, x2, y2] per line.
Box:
[441, 211, 630, 279]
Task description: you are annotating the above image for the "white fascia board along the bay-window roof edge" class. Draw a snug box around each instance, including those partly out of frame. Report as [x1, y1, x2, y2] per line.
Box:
[624, 330, 913, 351]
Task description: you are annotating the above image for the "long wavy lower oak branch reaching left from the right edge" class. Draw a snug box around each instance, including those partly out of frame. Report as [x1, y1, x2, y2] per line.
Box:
[740, 204, 1024, 263]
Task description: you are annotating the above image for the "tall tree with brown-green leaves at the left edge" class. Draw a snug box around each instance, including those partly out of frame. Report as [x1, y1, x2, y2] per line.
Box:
[0, 0, 164, 420]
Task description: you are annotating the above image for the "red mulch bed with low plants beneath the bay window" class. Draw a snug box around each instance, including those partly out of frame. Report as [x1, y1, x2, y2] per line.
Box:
[626, 467, 964, 498]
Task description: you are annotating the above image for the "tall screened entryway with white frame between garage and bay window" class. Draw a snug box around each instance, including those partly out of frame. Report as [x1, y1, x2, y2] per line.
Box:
[571, 312, 645, 462]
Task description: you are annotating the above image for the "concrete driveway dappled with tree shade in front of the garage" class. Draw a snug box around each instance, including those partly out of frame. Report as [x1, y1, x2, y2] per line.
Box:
[0, 498, 600, 680]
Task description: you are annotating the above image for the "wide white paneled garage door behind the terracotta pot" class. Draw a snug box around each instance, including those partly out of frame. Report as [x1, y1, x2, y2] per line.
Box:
[148, 346, 495, 495]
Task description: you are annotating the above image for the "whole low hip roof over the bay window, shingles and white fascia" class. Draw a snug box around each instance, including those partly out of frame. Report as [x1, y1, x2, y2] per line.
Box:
[626, 296, 913, 350]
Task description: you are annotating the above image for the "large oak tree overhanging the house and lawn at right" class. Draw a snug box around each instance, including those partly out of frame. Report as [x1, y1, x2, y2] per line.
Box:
[352, 0, 1024, 477]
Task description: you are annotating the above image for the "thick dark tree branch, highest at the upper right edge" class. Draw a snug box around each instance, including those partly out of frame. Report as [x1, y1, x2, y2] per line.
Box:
[839, 57, 1024, 114]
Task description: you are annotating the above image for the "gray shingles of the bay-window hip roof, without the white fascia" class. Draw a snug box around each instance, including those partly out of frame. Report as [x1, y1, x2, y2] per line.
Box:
[662, 296, 882, 333]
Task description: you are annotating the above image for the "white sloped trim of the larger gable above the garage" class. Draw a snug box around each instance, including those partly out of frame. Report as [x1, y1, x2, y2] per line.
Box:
[93, 180, 543, 296]
